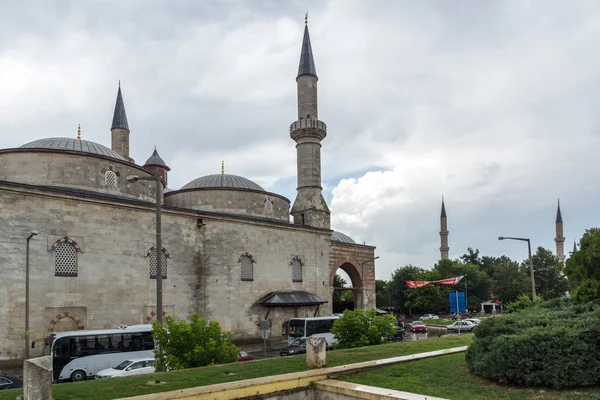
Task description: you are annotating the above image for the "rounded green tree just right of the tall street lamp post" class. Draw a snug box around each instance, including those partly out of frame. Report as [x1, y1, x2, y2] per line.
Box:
[523, 247, 569, 300]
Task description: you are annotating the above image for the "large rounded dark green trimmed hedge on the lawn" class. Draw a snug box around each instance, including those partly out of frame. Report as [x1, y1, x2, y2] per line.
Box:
[466, 299, 600, 389]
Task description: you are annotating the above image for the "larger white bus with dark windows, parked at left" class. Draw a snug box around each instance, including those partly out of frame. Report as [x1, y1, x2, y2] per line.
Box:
[44, 325, 154, 383]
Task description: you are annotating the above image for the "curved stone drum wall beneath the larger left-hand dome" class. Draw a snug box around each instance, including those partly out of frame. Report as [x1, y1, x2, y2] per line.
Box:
[0, 150, 156, 202]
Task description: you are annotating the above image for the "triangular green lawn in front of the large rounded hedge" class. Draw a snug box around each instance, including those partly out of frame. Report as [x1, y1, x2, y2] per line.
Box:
[335, 354, 600, 400]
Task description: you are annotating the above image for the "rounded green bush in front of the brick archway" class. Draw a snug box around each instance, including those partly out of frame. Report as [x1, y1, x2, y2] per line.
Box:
[331, 309, 396, 348]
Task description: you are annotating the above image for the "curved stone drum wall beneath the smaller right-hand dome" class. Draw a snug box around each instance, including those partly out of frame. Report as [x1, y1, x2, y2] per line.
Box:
[165, 188, 290, 222]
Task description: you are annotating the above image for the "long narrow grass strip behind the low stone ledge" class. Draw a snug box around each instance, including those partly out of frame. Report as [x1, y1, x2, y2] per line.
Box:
[0, 335, 472, 400]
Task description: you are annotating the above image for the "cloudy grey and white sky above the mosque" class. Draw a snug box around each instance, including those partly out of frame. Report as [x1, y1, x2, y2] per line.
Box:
[0, 0, 600, 279]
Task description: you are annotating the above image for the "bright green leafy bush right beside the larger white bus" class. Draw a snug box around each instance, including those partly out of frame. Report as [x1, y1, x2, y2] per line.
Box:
[152, 314, 239, 371]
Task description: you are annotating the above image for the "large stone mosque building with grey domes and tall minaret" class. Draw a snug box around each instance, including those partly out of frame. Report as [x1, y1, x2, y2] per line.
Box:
[0, 20, 375, 360]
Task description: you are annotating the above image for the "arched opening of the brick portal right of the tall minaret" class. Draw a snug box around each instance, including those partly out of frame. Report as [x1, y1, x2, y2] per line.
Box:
[330, 262, 362, 314]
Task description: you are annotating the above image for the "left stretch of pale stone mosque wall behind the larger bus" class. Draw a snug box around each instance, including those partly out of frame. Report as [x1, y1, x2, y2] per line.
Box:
[0, 185, 202, 359]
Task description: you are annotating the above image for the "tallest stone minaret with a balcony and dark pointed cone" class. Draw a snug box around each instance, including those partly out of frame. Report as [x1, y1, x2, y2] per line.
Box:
[290, 14, 331, 229]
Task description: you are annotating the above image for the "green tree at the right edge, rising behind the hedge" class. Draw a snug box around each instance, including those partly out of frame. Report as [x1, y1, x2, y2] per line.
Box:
[565, 228, 600, 302]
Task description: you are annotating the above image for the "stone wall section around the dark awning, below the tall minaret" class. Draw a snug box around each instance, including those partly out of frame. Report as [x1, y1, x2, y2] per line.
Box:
[202, 220, 331, 339]
